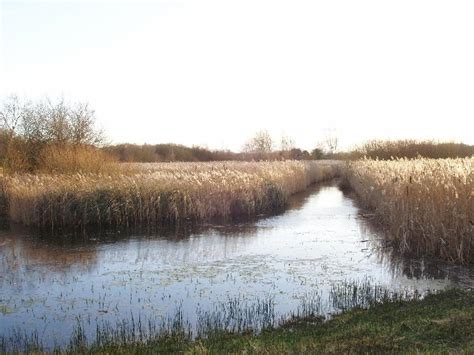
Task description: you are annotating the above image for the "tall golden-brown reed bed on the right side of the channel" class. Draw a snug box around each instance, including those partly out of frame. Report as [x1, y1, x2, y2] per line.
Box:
[345, 158, 474, 263]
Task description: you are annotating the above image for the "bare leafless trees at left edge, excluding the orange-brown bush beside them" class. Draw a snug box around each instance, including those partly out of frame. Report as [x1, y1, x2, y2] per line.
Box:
[0, 95, 104, 170]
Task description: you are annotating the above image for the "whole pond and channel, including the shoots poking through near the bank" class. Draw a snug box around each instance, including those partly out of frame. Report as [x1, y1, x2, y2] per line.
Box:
[0, 183, 474, 351]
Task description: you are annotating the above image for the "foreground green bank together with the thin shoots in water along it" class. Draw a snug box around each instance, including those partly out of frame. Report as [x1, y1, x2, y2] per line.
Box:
[5, 283, 468, 353]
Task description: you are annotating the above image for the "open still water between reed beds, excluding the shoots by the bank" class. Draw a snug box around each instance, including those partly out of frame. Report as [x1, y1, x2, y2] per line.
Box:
[0, 185, 474, 345]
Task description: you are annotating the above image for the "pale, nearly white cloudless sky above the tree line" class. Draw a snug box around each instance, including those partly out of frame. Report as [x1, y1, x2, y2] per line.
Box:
[0, 0, 474, 151]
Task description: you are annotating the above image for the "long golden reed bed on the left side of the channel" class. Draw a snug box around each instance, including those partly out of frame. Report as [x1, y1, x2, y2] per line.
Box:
[2, 161, 337, 231]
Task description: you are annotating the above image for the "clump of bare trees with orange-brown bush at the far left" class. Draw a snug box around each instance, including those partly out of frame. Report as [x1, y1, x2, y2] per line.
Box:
[0, 96, 110, 173]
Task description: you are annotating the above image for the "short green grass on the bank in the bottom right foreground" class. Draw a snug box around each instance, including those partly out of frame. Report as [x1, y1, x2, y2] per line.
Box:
[55, 290, 474, 354]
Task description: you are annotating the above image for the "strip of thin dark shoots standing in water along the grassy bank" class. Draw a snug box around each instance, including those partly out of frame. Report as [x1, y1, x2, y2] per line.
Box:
[0, 280, 433, 353]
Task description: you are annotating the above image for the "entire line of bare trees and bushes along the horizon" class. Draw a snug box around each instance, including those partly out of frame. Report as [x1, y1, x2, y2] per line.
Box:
[0, 96, 474, 172]
